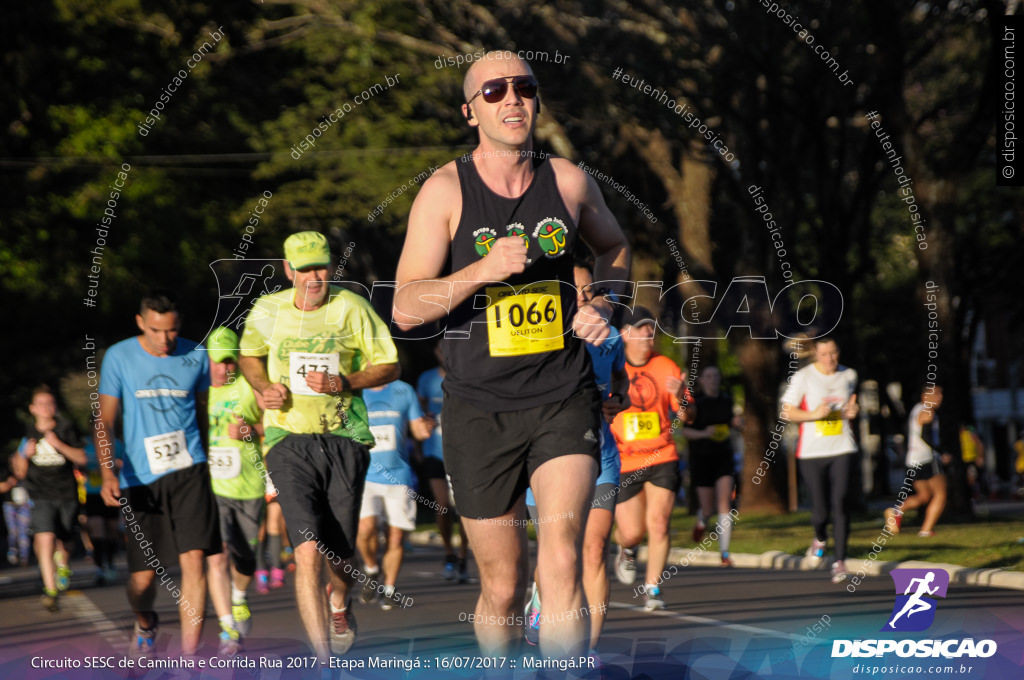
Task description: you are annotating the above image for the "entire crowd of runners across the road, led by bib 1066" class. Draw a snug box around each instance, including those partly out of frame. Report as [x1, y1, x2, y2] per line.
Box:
[0, 50, 962, 661]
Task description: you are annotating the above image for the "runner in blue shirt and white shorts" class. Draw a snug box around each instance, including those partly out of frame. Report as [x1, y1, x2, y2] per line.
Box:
[356, 380, 434, 610]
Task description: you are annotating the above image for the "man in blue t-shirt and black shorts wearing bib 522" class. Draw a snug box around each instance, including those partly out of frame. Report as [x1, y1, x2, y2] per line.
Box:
[93, 294, 221, 655]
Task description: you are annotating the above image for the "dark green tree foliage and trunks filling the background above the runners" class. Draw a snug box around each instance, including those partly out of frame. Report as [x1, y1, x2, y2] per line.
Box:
[0, 0, 1021, 520]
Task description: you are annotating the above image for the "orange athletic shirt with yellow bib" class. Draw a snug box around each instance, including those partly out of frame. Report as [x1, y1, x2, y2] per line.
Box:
[611, 353, 693, 472]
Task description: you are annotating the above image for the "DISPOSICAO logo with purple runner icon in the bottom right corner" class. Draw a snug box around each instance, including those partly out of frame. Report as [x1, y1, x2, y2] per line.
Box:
[831, 569, 996, 658]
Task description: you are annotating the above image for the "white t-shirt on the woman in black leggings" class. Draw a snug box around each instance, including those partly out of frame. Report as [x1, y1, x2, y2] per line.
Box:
[782, 364, 857, 458]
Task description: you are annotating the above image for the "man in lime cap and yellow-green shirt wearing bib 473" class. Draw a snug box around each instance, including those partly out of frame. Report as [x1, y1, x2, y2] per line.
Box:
[240, 231, 399, 663]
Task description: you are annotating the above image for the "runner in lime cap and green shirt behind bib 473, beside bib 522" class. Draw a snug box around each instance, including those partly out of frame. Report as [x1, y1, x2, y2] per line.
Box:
[206, 326, 267, 656]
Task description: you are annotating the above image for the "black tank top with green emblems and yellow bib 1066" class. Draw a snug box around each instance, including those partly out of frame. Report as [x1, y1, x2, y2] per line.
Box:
[444, 156, 591, 412]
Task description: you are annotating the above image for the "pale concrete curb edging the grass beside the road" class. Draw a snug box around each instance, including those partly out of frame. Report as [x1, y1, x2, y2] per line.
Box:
[408, 532, 1024, 590]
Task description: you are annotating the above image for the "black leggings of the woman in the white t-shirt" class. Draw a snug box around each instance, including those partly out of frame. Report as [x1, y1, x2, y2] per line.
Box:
[800, 453, 857, 561]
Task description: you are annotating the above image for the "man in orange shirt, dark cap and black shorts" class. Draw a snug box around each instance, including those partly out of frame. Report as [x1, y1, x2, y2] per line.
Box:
[611, 306, 693, 611]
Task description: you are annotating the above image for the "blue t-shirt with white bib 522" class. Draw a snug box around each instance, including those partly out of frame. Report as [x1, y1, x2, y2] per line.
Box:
[99, 337, 210, 486]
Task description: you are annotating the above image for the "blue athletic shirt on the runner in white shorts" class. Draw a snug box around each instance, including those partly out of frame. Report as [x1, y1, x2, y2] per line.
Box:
[362, 380, 423, 486]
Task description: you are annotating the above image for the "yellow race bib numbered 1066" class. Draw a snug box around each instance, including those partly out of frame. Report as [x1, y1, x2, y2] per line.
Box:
[485, 281, 565, 356]
